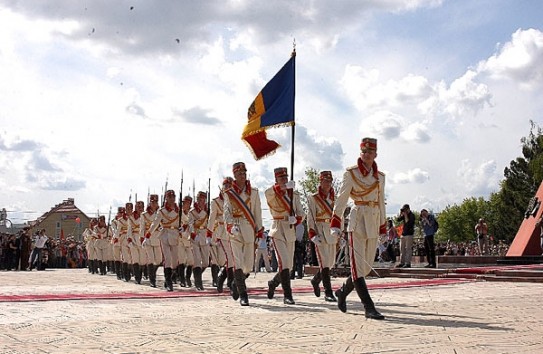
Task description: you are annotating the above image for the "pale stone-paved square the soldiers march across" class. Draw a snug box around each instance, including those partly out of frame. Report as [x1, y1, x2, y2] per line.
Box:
[0, 269, 543, 353]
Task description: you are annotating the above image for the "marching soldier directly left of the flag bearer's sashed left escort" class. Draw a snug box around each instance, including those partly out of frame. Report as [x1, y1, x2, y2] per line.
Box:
[207, 177, 239, 300]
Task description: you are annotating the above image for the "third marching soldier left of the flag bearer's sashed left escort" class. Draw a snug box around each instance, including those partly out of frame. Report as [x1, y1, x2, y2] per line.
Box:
[177, 195, 194, 288]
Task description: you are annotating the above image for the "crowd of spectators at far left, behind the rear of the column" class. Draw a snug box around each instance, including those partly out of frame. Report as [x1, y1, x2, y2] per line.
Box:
[0, 229, 87, 271]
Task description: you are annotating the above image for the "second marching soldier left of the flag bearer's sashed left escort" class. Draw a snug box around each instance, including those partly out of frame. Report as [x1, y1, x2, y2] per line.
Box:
[189, 191, 211, 290]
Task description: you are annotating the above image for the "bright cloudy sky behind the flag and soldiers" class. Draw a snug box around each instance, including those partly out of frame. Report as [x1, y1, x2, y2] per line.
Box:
[0, 0, 543, 227]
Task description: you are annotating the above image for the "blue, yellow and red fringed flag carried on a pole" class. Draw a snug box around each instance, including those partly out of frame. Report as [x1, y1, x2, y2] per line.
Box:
[241, 52, 296, 160]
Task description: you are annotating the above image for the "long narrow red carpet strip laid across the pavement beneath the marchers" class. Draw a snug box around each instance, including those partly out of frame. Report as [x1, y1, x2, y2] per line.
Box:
[0, 279, 470, 302]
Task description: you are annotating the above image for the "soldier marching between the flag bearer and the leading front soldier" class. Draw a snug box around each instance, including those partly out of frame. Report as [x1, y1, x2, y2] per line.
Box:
[307, 171, 337, 302]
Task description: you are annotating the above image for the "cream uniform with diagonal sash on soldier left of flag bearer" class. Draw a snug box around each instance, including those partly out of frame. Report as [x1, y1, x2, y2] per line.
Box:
[224, 185, 264, 274]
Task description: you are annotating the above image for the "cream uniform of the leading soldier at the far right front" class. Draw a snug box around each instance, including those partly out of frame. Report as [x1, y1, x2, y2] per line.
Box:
[333, 165, 386, 280]
